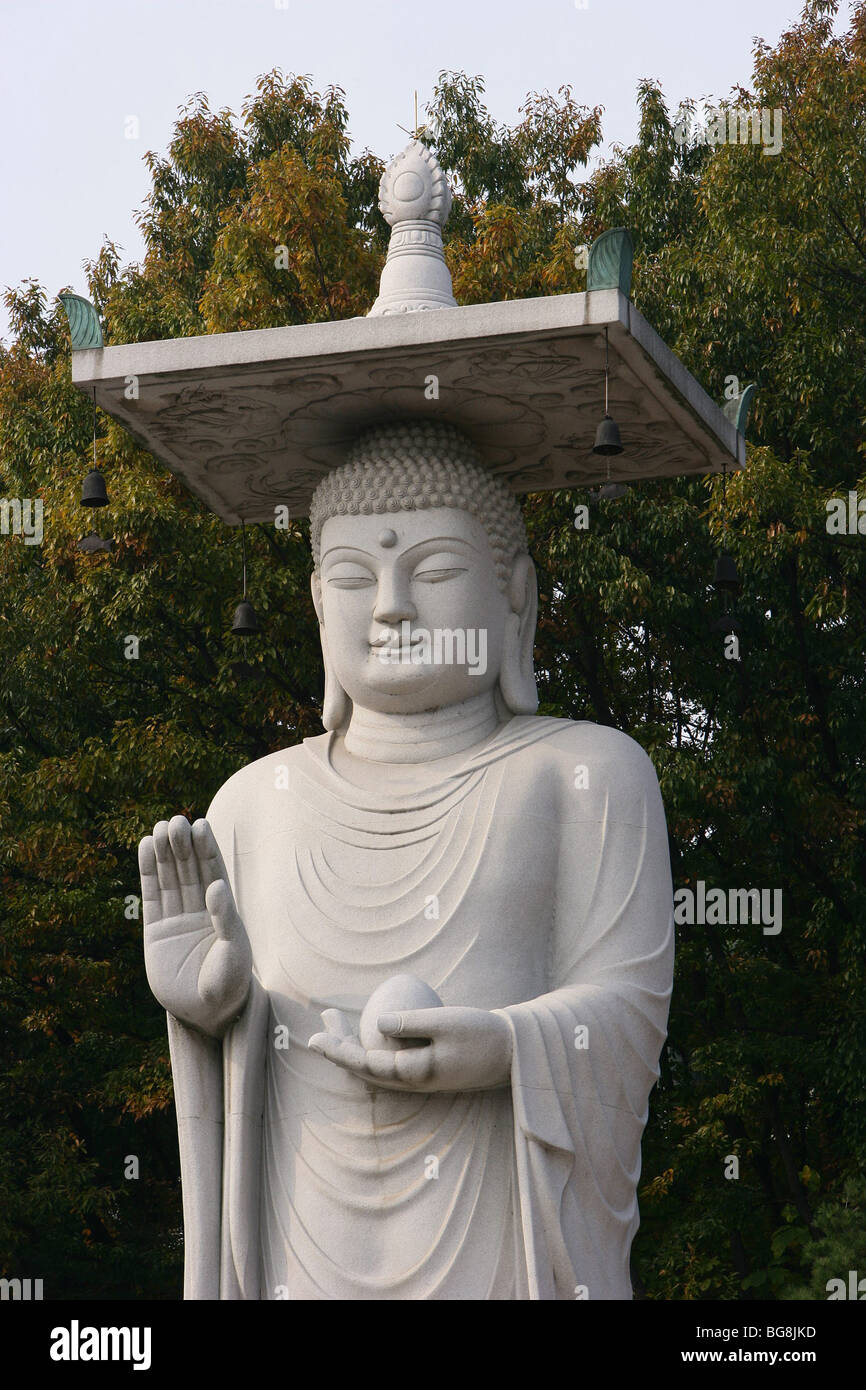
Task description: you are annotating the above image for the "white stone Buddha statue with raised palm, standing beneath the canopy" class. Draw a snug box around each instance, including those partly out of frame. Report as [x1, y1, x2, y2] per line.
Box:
[139, 421, 673, 1301]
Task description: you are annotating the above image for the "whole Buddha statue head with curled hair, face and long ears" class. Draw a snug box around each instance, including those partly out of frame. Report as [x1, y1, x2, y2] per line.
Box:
[310, 423, 538, 731]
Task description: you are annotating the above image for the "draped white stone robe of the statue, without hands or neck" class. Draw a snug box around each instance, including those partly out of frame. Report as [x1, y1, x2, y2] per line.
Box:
[168, 716, 673, 1300]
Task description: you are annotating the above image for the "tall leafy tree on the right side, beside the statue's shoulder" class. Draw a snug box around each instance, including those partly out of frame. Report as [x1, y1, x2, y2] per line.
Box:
[569, 4, 866, 1297]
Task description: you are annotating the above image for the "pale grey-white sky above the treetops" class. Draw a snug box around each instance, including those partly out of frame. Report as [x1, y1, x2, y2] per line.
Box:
[0, 0, 848, 335]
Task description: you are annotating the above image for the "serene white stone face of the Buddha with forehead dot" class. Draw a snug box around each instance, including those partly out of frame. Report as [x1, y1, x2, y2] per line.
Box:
[313, 507, 510, 714]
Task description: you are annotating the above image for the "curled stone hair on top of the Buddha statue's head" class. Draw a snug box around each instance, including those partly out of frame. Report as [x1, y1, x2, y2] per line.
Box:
[310, 423, 528, 589]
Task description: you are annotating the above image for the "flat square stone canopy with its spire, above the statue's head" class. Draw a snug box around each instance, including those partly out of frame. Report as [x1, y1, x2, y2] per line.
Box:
[72, 142, 745, 525]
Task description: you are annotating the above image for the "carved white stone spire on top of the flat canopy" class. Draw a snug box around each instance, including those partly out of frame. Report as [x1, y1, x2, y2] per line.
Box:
[367, 140, 457, 318]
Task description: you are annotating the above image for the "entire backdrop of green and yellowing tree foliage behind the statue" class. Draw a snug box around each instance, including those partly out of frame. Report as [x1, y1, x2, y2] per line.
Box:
[0, 3, 866, 1300]
